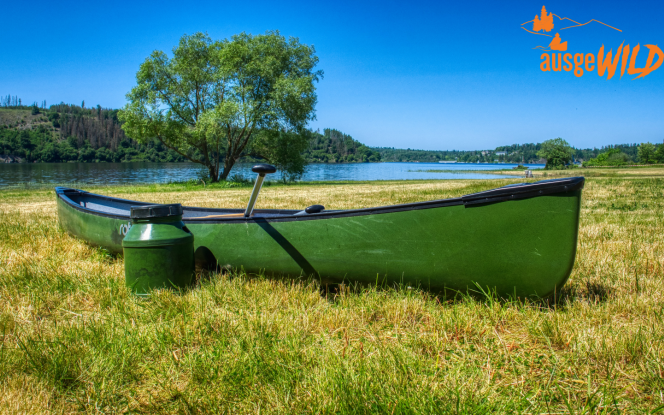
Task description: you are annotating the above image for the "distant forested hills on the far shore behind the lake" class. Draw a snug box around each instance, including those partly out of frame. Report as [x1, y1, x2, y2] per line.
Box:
[0, 96, 652, 167]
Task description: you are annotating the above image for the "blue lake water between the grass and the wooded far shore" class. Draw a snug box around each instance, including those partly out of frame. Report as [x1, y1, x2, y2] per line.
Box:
[0, 162, 544, 186]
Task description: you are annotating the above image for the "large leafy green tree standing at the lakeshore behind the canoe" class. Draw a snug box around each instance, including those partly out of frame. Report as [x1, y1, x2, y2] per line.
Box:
[119, 32, 323, 181]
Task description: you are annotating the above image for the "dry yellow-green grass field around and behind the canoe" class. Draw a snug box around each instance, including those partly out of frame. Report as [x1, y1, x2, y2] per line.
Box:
[0, 174, 664, 414]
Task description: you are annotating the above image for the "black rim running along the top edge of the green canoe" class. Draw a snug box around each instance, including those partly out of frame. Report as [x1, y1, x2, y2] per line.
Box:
[55, 177, 585, 224]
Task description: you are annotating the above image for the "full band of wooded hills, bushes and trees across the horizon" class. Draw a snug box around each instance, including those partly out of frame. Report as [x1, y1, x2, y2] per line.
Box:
[0, 95, 664, 172]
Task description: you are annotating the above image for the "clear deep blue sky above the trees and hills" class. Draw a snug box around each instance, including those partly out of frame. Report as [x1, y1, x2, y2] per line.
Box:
[0, 0, 664, 150]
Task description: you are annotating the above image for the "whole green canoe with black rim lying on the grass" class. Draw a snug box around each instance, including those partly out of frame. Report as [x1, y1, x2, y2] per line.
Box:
[56, 177, 584, 297]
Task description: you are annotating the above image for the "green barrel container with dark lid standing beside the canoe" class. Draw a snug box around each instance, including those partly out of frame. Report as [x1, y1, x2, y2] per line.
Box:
[122, 204, 194, 296]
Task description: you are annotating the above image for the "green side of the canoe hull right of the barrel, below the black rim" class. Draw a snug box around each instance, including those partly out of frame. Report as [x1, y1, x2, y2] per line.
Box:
[187, 191, 580, 297]
